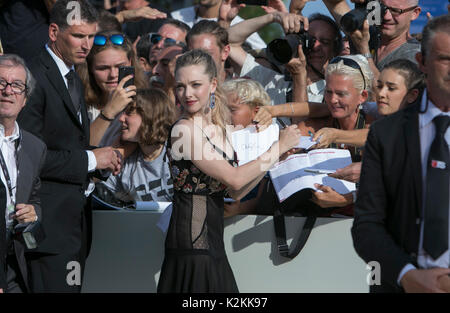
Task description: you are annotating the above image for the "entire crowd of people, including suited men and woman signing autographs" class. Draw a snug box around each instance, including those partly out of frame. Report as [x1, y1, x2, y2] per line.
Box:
[0, 0, 450, 293]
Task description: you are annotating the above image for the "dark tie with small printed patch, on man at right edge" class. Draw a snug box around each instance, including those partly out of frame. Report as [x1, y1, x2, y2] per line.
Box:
[423, 115, 450, 259]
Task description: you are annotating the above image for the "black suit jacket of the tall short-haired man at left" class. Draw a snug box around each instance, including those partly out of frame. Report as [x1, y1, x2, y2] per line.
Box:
[18, 48, 89, 254]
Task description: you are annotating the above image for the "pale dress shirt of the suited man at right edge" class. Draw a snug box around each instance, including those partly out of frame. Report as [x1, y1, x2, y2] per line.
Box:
[398, 90, 450, 283]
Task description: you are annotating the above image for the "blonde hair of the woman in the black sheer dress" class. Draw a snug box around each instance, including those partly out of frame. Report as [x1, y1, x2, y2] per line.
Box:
[175, 49, 230, 134]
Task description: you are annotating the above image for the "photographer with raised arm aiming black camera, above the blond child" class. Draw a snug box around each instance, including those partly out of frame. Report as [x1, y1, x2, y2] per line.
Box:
[229, 8, 342, 118]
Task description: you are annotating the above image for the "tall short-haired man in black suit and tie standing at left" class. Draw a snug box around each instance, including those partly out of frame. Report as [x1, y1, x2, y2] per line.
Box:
[18, 0, 120, 292]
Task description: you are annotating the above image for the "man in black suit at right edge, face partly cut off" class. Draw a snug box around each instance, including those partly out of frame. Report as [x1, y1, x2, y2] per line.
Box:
[352, 15, 450, 292]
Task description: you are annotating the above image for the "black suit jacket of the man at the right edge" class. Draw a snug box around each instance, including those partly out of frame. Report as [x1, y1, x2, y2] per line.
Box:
[352, 103, 422, 292]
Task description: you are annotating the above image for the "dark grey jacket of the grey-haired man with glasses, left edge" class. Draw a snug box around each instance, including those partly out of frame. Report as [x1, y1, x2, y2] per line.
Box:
[0, 130, 46, 290]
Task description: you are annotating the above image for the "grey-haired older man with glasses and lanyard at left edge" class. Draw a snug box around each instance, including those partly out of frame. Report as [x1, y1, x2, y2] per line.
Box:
[0, 54, 46, 293]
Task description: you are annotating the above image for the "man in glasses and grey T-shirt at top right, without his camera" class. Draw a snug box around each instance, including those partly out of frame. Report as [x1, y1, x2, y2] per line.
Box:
[323, 0, 421, 79]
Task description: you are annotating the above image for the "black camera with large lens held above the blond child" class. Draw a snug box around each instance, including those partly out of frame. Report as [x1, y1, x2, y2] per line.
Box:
[267, 30, 316, 65]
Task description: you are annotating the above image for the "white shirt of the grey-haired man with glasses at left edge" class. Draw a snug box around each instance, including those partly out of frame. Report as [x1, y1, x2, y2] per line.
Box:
[0, 122, 20, 230]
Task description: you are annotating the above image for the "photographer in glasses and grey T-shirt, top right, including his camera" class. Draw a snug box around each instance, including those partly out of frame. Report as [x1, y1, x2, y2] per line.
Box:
[323, 0, 421, 79]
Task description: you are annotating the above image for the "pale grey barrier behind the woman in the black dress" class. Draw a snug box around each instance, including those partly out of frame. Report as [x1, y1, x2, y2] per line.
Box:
[82, 207, 369, 293]
